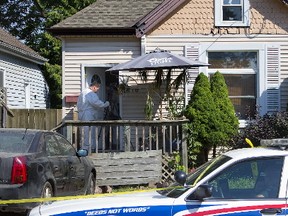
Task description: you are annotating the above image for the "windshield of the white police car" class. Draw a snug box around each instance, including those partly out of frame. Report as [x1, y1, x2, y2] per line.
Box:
[158, 155, 231, 198]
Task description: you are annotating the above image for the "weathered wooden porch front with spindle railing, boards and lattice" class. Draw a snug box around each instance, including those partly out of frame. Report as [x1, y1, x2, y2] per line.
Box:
[55, 120, 188, 186]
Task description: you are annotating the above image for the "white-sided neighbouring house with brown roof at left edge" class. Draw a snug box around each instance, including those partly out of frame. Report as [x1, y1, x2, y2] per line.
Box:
[0, 28, 49, 109]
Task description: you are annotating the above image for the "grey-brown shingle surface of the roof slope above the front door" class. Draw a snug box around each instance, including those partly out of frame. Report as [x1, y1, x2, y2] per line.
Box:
[51, 0, 164, 30]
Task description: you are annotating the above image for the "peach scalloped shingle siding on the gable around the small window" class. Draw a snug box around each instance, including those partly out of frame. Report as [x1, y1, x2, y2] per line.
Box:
[149, 0, 288, 35]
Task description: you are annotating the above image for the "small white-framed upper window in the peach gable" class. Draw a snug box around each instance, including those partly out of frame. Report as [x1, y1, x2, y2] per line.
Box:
[214, 0, 250, 27]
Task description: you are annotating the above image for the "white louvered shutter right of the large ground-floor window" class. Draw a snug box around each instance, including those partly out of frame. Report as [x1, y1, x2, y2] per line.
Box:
[266, 46, 280, 113]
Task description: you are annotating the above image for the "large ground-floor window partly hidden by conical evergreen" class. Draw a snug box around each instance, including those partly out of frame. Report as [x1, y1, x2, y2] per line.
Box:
[208, 51, 258, 120]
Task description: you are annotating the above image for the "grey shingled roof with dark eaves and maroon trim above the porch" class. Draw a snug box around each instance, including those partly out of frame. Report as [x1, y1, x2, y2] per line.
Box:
[49, 0, 189, 37]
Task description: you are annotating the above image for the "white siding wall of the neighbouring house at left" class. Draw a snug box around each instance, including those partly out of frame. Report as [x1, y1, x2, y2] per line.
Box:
[0, 52, 49, 109]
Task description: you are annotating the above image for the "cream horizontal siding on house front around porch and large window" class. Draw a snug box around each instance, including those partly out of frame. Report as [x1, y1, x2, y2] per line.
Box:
[63, 35, 288, 119]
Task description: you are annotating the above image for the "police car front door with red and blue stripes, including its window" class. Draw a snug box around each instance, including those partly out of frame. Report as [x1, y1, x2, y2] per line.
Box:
[173, 157, 287, 216]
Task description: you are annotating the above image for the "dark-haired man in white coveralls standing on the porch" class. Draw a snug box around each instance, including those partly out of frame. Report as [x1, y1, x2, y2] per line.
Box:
[77, 81, 110, 152]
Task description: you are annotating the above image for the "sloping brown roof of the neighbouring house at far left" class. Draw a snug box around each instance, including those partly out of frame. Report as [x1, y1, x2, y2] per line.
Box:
[0, 28, 48, 64]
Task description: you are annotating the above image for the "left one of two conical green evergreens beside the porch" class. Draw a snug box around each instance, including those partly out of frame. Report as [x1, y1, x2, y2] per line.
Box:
[184, 73, 217, 163]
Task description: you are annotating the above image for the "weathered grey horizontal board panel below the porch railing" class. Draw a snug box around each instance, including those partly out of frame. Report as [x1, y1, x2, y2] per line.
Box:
[90, 150, 162, 186]
